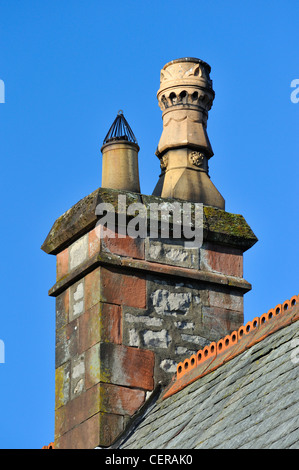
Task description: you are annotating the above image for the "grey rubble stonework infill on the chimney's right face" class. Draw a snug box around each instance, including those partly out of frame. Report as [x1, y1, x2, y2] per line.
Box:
[123, 240, 243, 383]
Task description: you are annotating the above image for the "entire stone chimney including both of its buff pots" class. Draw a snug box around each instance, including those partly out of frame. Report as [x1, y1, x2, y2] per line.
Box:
[42, 59, 257, 449]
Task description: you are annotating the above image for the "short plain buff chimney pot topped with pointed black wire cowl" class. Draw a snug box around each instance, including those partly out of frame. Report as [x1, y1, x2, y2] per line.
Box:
[101, 110, 140, 193]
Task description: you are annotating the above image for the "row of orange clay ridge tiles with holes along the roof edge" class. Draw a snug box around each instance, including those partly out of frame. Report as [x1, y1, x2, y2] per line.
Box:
[163, 295, 299, 399]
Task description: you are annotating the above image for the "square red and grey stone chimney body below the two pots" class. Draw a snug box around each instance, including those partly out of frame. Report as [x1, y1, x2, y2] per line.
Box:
[42, 188, 257, 448]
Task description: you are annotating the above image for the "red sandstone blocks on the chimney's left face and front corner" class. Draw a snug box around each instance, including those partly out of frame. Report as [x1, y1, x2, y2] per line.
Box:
[55, 229, 158, 448]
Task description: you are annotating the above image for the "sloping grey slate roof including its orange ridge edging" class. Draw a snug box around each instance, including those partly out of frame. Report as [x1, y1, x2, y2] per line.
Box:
[112, 296, 299, 449]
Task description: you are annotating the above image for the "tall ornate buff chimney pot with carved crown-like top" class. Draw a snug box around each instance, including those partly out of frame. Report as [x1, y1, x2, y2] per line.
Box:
[153, 57, 225, 209]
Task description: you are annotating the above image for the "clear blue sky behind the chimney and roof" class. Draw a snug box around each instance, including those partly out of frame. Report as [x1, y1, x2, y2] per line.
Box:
[0, 0, 299, 449]
